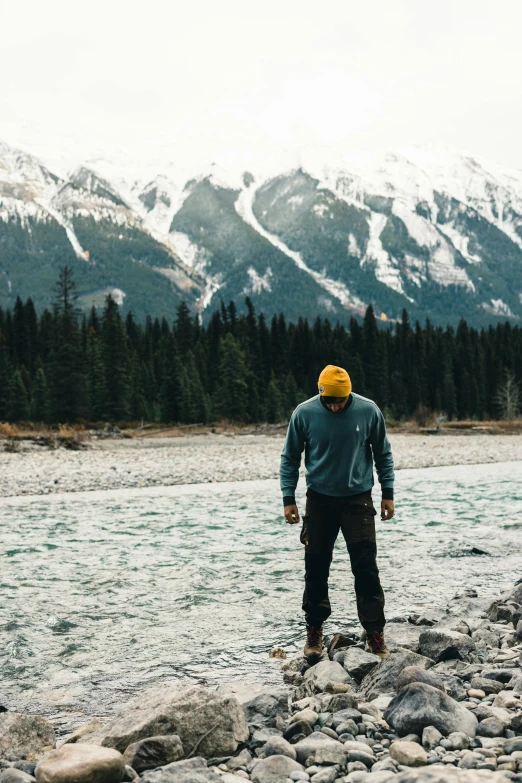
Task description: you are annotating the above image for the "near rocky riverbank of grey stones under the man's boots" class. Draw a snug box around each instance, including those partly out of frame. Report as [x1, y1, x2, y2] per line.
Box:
[0, 580, 522, 783]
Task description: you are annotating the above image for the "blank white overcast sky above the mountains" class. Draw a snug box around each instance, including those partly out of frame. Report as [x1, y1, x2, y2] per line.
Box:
[0, 0, 522, 175]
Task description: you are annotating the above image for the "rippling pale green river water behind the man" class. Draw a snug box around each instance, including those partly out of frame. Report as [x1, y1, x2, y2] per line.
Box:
[0, 462, 522, 730]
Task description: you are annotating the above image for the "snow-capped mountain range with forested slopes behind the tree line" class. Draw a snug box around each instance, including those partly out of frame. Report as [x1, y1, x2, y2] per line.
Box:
[0, 138, 522, 324]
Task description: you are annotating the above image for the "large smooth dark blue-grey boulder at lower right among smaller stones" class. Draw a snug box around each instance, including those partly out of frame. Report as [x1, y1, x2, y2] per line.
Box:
[384, 682, 478, 737]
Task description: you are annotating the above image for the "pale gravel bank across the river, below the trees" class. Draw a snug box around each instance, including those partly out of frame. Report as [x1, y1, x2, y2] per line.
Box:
[0, 433, 522, 497]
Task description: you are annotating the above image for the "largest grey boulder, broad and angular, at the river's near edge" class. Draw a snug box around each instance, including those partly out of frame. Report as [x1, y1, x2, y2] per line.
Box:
[101, 686, 249, 758]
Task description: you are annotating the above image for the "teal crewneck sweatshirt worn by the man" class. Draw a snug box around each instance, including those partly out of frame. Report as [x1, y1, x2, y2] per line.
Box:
[280, 392, 394, 498]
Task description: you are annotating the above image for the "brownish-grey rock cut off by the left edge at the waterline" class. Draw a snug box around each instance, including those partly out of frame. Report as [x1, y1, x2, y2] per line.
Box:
[0, 712, 55, 761]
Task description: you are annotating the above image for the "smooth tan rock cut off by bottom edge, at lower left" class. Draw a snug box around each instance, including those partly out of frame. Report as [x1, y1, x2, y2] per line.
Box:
[36, 742, 125, 783]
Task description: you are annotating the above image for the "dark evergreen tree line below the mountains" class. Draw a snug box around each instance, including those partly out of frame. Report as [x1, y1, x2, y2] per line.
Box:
[0, 267, 522, 424]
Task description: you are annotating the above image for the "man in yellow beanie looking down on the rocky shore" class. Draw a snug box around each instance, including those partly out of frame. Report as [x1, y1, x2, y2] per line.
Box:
[281, 364, 394, 663]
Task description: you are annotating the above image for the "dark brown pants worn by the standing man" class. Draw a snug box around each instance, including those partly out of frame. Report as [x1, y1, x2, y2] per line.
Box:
[301, 489, 386, 634]
